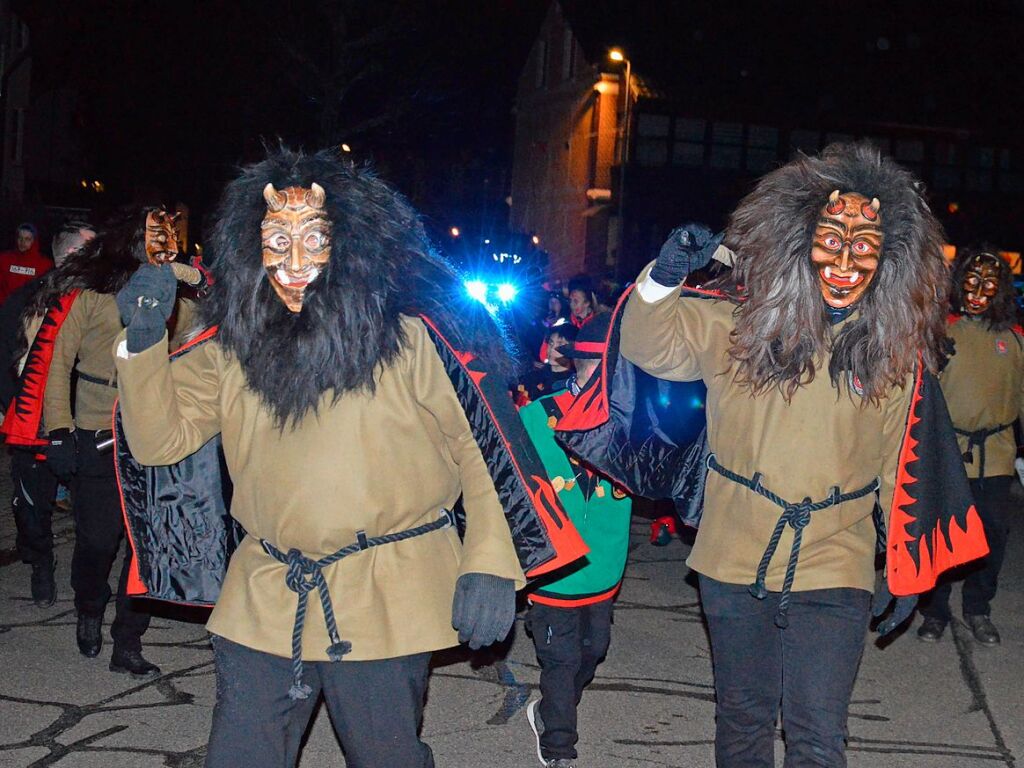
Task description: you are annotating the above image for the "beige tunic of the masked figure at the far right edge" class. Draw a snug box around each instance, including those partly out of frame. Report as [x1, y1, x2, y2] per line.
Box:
[939, 317, 1024, 477]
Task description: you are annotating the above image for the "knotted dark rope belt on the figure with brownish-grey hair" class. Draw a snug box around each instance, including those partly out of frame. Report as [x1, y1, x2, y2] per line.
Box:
[708, 454, 879, 629]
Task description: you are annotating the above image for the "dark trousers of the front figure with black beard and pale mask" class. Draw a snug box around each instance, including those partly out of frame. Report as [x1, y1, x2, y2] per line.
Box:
[206, 637, 434, 768]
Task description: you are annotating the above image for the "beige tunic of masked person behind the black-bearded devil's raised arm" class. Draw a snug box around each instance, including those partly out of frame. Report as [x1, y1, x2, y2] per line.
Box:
[43, 291, 195, 431]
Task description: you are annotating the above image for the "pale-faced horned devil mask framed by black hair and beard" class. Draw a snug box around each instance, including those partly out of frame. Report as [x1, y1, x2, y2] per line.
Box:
[260, 182, 331, 312]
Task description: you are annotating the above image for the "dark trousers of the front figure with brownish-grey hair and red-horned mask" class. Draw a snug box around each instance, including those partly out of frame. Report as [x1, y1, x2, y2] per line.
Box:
[700, 575, 871, 768]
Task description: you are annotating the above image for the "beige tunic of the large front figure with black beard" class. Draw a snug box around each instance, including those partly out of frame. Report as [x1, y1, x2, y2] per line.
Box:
[117, 317, 525, 660]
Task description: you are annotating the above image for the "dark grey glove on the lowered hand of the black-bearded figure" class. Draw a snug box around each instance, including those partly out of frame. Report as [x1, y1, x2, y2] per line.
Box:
[452, 573, 515, 650]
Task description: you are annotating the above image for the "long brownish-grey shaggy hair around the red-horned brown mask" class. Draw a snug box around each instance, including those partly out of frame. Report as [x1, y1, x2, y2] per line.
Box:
[722, 142, 949, 403]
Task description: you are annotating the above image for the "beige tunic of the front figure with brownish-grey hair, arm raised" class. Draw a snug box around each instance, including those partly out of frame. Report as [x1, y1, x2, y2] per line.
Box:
[621, 270, 912, 591]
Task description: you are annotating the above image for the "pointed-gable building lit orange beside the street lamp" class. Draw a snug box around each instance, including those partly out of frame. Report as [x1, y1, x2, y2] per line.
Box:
[510, 3, 618, 279]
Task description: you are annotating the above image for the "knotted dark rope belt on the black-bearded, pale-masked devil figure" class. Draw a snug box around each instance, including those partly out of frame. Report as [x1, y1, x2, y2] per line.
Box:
[259, 509, 455, 700]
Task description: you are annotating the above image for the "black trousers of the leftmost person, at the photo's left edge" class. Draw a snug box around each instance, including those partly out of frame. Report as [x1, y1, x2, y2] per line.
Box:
[10, 449, 57, 564]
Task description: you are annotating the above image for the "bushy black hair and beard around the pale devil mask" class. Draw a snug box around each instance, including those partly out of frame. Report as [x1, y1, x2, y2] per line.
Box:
[202, 147, 512, 429]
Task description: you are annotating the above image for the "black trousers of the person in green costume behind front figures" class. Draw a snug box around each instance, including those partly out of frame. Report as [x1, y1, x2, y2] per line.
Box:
[527, 600, 614, 760]
